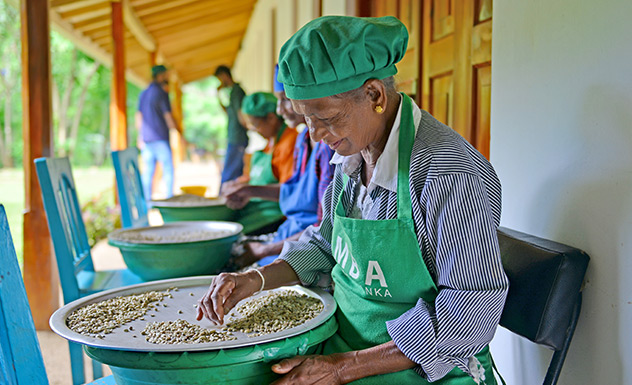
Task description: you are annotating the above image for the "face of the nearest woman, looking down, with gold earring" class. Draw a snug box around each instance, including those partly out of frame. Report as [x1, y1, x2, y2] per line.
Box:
[292, 81, 385, 156]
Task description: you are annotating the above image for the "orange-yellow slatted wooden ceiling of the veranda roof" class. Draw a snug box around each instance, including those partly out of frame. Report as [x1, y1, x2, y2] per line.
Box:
[9, 0, 256, 86]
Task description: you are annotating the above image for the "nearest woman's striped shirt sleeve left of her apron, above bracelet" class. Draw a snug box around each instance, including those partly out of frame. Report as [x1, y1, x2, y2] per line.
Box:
[279, 167, 343, 288]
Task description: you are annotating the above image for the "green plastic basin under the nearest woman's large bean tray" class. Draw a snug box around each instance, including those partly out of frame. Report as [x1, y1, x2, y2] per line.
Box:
[84, 316, 338, 385]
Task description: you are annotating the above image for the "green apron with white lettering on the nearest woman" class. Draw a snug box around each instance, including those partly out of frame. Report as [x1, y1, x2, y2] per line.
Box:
[323, 95, 496, 385]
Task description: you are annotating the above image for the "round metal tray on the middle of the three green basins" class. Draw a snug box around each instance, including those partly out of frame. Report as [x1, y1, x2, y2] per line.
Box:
[108, 221, 244, 246]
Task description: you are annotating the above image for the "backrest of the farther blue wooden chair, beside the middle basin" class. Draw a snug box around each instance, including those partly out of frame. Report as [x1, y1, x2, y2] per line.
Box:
[112, 147, 149, 228]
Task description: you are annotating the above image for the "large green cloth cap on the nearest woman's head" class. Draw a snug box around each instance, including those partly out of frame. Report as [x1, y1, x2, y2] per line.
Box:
[279, 16, 408, 99]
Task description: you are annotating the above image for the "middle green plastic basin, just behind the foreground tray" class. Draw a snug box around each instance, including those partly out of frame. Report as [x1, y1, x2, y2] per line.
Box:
[108, 221, 243, 281]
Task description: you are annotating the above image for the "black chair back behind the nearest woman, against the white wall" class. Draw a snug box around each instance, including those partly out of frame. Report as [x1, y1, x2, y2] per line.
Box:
[498, 228, 590, 384]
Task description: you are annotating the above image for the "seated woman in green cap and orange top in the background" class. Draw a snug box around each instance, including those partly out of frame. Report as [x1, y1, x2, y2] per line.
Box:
[222, 92, 298, 233]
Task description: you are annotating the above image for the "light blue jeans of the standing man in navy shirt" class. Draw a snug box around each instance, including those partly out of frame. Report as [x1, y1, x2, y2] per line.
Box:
[141, 140, 173, 201]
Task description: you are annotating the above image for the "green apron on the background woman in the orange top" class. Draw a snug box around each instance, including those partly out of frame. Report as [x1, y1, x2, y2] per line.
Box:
[237, 124, 286, 234]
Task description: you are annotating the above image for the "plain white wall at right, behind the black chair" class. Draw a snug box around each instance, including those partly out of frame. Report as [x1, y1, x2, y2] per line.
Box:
[491, 0, 632, 385]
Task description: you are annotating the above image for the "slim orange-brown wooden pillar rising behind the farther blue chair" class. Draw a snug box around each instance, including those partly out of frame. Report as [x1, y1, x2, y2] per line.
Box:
[110, 0, 127, 150]
